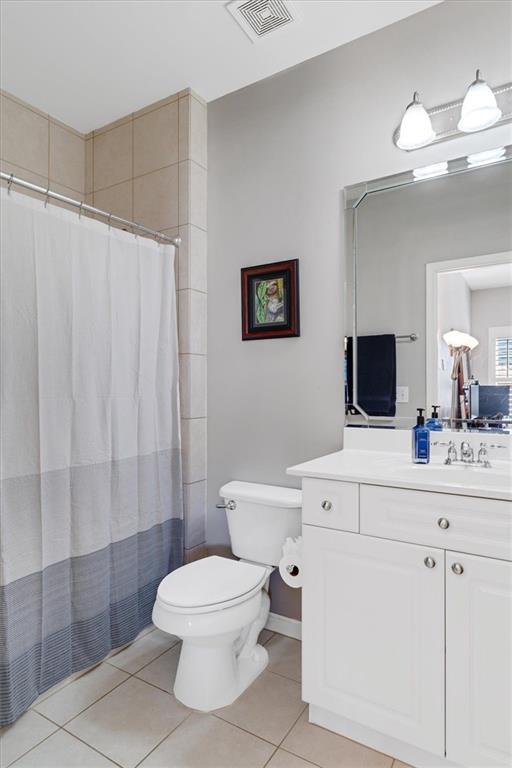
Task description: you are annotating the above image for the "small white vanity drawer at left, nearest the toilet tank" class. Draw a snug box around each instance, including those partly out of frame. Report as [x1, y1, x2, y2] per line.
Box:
[302, 478, 359, 532]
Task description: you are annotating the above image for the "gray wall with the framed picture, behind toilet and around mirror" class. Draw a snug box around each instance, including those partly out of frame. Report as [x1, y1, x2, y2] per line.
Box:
[208, 1, 512, 615]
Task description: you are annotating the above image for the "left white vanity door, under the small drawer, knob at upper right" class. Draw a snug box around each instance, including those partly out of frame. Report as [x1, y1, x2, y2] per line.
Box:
[302, 525, 444, 755]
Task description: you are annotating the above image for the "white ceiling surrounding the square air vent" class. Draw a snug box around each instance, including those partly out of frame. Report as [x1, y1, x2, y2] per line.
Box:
[1, 0, 440, 132]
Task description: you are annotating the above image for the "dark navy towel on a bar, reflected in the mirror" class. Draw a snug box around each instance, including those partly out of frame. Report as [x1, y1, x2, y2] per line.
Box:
[346, 333, 396, 416]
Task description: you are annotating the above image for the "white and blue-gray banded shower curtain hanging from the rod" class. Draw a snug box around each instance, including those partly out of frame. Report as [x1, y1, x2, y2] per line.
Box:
[0, 189, 183, 724]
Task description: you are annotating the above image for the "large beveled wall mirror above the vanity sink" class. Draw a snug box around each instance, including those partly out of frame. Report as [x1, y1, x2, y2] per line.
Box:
[345, 147, 512, 431]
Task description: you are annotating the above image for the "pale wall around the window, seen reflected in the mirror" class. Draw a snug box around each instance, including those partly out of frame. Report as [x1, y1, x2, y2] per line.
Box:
[471, 286, 512, 384]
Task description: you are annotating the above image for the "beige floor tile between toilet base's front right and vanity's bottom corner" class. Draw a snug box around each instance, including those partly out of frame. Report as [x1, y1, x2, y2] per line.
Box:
[215, 672, 306, 744]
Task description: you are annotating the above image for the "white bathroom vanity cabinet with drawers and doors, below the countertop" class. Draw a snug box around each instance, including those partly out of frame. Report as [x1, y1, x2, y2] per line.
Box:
[302, 478, 512, 768]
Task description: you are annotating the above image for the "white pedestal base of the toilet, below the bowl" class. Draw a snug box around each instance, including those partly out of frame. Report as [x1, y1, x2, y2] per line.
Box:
[174, 636, 268, 712]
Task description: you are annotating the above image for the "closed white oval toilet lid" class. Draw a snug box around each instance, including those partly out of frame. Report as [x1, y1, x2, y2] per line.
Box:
[158, 555, 269, 608]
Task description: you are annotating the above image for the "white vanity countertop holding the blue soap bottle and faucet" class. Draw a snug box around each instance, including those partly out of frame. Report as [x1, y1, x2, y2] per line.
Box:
[286, 449, 512, 501]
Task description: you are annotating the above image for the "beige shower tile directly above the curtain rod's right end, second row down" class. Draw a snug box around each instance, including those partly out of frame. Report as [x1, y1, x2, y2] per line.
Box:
[134, 165, 178, 230]
